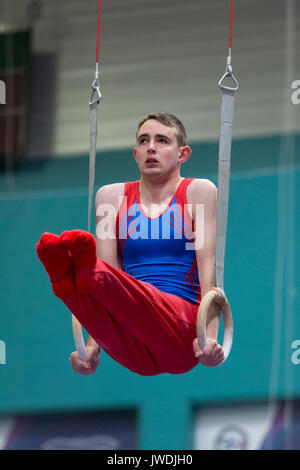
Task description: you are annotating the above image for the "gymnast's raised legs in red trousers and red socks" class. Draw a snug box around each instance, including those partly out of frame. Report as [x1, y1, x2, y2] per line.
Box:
[36, 230, 199, 376]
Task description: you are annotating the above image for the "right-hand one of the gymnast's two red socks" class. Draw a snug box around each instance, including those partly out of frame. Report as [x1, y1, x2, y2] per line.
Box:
[60, 230, 97, 293]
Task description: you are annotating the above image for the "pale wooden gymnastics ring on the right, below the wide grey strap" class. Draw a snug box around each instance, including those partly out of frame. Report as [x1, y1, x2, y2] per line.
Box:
[197, 287, 233, 363]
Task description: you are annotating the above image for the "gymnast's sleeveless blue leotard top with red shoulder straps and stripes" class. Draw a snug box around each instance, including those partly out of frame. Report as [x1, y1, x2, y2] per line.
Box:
[117, 179, 200, 303]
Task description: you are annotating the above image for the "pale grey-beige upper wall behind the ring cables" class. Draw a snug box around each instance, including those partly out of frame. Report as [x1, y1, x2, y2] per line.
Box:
[0, 0, 300, 158]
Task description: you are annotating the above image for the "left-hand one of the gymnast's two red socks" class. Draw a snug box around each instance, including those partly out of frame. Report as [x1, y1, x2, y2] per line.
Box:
[36, 233, 75, 298]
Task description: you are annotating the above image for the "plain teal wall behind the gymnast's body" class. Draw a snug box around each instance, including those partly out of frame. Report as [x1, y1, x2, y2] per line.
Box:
[0, 136, 300, 449]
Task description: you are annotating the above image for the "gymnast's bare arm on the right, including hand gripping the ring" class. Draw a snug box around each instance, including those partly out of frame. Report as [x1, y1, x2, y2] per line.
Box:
[187, 179, 223, 366]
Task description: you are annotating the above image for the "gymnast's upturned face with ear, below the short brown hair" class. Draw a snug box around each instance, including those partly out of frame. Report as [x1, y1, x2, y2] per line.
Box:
[133, 119, 191, 176]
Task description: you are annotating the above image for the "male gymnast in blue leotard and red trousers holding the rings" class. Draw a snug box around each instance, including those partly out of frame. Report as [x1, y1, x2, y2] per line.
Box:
[36, 113, 224, 376]
